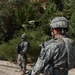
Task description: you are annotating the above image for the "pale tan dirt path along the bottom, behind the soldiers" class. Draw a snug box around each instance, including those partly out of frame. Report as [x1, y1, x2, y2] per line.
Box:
[0, 60, 75, 75]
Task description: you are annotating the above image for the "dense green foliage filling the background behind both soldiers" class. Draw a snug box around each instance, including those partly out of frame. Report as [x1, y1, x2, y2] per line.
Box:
[0, 0, 75, 60]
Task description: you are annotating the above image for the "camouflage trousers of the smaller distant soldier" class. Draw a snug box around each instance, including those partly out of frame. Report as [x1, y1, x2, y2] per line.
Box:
[17, 54, 26, 74]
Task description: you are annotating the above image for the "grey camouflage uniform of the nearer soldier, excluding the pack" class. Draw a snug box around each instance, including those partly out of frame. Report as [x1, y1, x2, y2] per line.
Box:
[32, 36, 68, 75]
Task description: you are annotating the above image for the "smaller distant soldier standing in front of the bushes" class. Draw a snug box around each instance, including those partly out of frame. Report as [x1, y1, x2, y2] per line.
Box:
[17, 34, 30, 75]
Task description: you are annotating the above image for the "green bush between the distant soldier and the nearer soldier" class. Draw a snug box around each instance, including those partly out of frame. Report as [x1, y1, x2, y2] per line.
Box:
[22, 27, 47, 61]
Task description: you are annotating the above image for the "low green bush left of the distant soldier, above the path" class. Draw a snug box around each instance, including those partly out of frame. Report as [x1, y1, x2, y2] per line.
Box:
[0, 37, 19, 61]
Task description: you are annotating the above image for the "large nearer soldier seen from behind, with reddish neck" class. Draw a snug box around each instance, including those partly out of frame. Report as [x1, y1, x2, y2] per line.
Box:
[29, 17, 75, 75]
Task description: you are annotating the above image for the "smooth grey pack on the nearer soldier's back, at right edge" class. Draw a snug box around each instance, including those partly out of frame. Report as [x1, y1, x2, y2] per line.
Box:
[63, 38, 75, 69]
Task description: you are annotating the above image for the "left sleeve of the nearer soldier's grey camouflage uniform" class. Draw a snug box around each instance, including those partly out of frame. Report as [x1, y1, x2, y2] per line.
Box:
[31, 45, 54, 75]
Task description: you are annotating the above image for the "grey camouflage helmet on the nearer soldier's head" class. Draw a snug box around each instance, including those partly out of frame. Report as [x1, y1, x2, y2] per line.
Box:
[50, 17, 69, 30]
